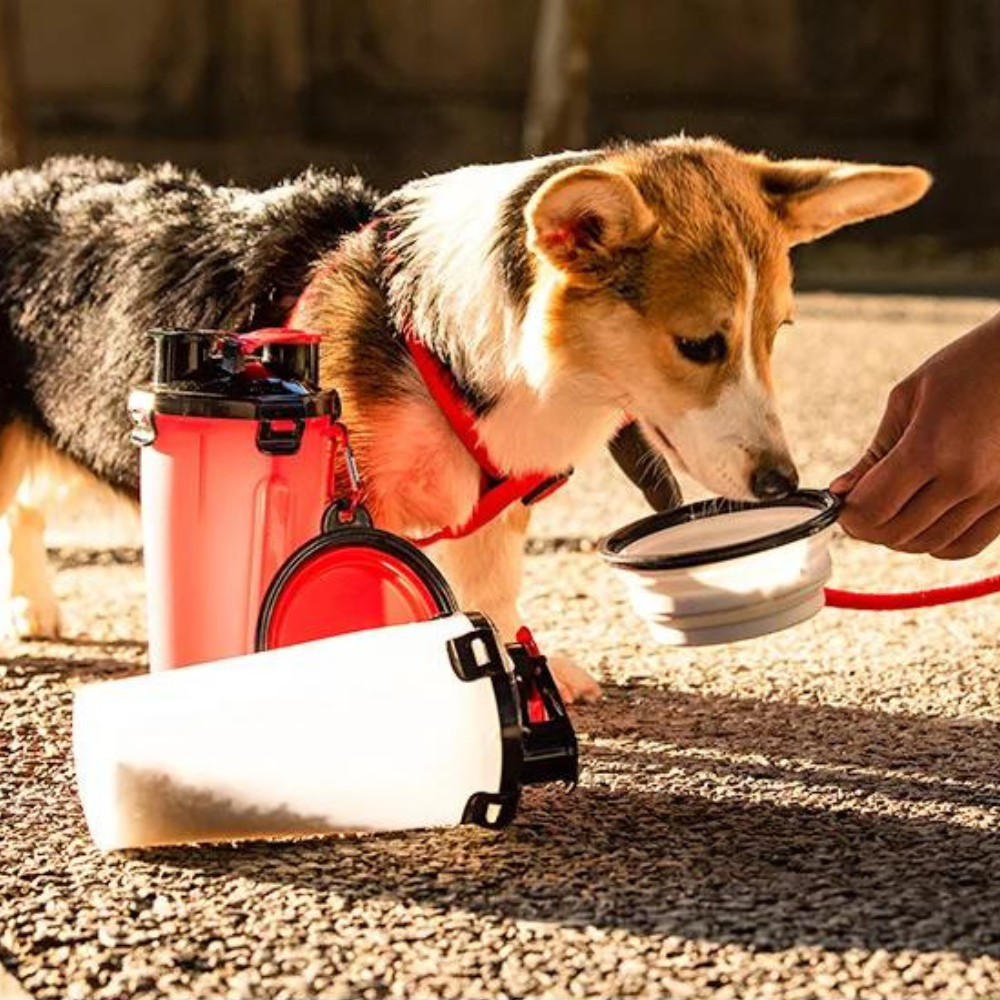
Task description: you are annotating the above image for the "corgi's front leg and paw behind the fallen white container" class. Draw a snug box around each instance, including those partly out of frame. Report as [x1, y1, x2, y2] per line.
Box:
[430, 504, 601, 703]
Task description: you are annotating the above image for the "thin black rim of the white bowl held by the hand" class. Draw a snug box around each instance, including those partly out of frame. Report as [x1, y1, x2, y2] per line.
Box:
[598, 490, 843, 571]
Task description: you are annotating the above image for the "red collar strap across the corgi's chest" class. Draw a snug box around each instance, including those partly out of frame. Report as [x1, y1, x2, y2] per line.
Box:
[404, 325, 573, 547]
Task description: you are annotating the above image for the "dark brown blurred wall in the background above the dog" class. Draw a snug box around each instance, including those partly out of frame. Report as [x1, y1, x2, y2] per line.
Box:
[0, 0, 1000, 258]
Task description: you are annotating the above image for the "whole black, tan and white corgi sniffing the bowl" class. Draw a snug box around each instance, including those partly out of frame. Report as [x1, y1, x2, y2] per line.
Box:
[0, 143, 930, 700]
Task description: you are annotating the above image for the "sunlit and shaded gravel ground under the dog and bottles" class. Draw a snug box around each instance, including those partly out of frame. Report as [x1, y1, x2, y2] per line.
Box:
[0, 295, 1000, 998]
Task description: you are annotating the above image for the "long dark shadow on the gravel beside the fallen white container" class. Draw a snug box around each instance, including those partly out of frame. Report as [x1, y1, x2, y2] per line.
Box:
[56, 672, 1000, 956]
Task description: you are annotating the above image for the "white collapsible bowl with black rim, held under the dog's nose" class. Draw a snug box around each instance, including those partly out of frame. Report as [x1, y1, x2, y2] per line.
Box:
[601, 490, 840, 646]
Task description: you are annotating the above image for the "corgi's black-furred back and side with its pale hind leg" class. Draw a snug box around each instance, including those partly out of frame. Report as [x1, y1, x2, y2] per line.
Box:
[0, 158, 375, 637]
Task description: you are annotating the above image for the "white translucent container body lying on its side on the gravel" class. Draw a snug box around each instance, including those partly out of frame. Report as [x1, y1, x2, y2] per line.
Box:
[73, 615, 520, 850]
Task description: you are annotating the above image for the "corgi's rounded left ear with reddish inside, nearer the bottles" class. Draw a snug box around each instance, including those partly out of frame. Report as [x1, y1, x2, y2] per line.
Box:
[525, 167, 656, 273]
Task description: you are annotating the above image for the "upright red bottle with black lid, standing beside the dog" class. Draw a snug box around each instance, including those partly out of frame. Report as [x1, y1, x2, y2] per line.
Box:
[129, 330, 339, 670]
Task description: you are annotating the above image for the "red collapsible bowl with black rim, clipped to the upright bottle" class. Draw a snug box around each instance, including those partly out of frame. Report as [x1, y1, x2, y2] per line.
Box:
[256, 527, 458, 651]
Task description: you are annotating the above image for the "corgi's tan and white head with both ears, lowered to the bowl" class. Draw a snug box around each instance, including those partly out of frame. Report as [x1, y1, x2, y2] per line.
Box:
[525, 139, 931, 499]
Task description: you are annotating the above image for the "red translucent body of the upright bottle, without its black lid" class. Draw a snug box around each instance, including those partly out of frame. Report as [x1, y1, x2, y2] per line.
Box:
[140, 414, 334, 670]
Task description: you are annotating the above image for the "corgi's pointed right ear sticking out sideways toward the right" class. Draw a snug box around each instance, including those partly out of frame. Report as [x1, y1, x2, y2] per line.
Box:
[758, 160, 932, 245]
